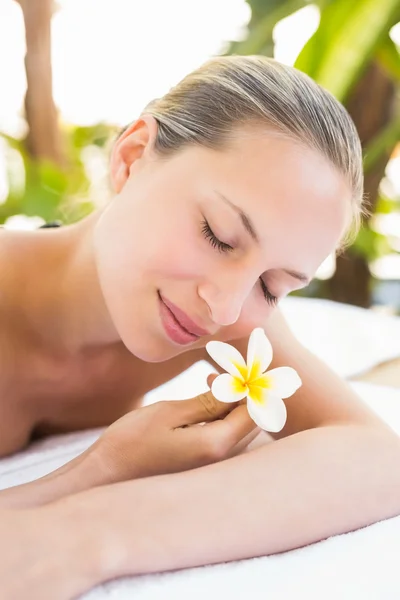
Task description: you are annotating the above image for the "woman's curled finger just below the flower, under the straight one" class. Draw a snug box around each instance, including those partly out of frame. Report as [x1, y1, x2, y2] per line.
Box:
[205, 404, 260, 452]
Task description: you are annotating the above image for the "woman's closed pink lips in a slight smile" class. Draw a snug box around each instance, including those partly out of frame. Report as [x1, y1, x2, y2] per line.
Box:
[158, 292, 209, 345]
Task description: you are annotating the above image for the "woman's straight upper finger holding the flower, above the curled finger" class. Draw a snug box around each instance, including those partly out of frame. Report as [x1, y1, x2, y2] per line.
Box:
[171, 390, 237, 427]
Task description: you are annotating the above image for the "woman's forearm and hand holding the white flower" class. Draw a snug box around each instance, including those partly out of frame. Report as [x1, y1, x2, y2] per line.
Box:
[0, 375, 259, 509]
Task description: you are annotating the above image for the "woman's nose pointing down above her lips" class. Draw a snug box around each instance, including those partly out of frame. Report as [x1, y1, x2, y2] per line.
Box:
[198, 273, 254, 327]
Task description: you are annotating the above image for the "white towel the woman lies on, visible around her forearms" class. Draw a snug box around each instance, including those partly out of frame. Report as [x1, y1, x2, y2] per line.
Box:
[0, 383, 400, 600]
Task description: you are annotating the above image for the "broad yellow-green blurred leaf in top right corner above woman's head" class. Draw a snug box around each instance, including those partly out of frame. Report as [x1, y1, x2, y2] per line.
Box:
[295, 0, 400, 102]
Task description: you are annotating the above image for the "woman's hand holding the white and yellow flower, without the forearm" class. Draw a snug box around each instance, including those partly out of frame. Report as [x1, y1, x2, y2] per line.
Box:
[89, 375, 260, 483]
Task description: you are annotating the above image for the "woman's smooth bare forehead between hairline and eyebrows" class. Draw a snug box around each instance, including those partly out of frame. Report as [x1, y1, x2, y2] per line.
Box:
[199, 133, 351, 274]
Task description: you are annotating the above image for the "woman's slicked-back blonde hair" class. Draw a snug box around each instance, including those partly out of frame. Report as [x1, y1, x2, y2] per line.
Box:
[139, 56, 367, 252]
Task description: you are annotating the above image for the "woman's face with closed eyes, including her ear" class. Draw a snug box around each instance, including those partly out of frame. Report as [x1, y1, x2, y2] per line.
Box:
[94, 117, 350, 362]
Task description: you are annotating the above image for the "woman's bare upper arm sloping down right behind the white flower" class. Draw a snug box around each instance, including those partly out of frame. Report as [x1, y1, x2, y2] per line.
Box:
[203, 308, 386, 439]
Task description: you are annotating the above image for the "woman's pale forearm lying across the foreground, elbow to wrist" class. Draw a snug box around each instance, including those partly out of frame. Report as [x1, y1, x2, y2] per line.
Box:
[52, 425, 400, 591]
